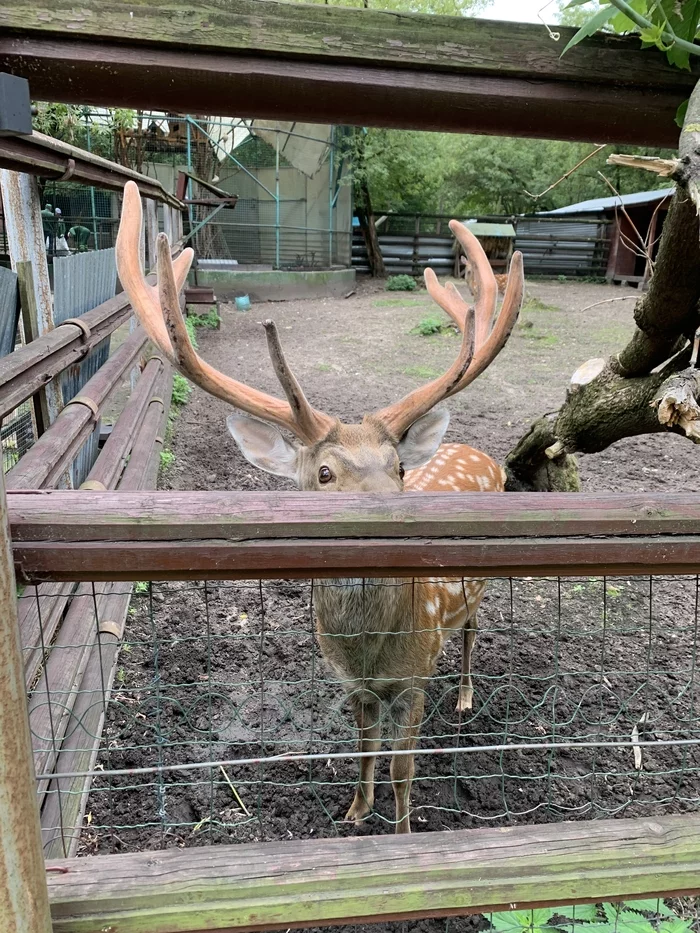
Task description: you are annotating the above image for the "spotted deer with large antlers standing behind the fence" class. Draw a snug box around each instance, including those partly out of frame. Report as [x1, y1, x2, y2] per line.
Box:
[116, 181, 524, 833]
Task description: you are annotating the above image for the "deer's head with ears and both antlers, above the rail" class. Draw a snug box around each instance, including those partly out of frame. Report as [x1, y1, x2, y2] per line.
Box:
[117, 181, 523, 492]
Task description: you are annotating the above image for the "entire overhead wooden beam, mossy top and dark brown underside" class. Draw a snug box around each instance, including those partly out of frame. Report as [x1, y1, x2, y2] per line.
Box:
[0, 0, 697, 147]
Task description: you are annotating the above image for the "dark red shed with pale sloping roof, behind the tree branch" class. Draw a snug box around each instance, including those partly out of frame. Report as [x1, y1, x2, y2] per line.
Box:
[540, 188, 675, 285]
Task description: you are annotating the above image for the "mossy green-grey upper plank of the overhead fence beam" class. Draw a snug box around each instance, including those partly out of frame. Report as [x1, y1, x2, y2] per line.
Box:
[0, 0, 700, 88]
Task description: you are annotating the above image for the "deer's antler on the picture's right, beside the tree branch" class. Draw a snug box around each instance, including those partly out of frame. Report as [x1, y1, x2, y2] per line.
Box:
[376, 220, 524, 437]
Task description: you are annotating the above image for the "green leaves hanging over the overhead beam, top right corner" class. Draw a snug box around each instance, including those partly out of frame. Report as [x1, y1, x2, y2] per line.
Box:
[564, 0, 700, 71]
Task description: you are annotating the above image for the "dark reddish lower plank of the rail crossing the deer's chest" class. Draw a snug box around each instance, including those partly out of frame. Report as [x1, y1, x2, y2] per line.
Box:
[14, 536, 700, 583]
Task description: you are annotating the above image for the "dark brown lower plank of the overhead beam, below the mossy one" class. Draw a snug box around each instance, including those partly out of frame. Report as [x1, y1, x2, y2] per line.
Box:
[0, 35, 690, 147]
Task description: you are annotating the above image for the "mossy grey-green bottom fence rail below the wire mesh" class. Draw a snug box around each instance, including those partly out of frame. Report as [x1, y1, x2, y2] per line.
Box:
[48, 814, 700, 933]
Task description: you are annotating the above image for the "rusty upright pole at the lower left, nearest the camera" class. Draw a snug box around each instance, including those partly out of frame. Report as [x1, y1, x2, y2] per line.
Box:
[0, 470, 51, 933]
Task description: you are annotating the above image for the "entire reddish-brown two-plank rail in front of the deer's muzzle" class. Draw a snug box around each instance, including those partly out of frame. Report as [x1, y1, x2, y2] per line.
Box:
[8, 491, 700, 582]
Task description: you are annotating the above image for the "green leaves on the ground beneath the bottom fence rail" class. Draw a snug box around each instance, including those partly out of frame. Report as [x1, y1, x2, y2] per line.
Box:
[490, 898, 691, 933]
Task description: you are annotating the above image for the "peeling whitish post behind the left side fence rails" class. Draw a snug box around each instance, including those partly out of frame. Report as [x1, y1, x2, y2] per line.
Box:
[0, 169, 63, 427]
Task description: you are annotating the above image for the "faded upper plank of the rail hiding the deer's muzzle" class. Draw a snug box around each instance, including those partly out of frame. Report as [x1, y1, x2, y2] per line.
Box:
[8, 490, 700, 542]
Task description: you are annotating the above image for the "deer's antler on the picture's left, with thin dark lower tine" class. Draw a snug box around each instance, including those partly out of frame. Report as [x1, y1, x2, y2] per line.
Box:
[117, 181, 335, 444]
